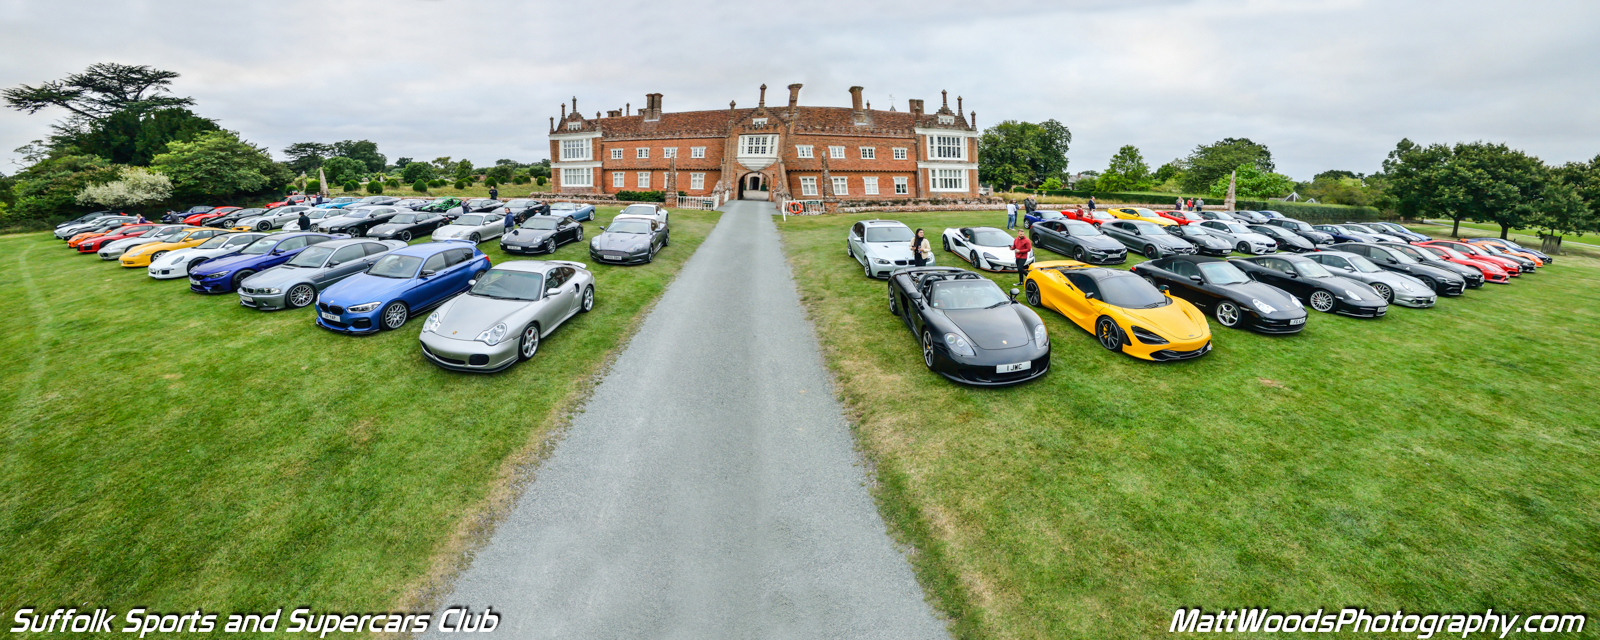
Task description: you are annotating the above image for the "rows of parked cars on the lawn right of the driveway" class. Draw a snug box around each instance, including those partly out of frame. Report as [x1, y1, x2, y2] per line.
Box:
[846, 208, 1554, 386]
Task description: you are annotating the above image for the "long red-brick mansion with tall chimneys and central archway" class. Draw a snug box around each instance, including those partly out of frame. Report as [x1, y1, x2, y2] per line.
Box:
[550, 85, 978, 202]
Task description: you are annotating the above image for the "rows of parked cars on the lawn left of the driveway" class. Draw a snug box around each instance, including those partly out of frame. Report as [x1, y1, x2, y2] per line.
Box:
[56, 197, 669, 371]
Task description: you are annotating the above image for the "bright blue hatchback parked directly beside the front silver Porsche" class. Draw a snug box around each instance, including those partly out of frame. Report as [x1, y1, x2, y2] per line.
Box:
[317, 240, 490, 334]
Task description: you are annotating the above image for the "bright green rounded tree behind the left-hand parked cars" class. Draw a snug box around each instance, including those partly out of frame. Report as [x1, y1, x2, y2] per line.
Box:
[150, 131, 281, 202]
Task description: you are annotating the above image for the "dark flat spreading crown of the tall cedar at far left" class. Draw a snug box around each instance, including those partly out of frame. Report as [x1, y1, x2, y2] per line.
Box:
[0, 62, 194, 136]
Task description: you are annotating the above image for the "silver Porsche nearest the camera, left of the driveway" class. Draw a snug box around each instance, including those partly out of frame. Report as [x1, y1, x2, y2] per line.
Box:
[418, 261, 595, 371]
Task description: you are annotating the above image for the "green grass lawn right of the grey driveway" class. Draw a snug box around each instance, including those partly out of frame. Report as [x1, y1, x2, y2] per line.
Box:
[781, 213, 1600, 638]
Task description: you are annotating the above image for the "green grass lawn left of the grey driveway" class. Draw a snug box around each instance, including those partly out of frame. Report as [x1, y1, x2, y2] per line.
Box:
[0, 208, 720, 629]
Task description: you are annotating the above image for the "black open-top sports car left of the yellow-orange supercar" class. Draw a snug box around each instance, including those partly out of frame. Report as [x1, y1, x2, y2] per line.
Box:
[888, 267, 1050, 386]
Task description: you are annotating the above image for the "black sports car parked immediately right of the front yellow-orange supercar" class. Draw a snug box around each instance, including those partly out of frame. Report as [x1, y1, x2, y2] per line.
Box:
[1130, 256, 1307, 333]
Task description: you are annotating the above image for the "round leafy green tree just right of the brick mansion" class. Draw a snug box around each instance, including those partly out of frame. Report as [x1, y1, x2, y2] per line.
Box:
[978, 120, 1072, 189]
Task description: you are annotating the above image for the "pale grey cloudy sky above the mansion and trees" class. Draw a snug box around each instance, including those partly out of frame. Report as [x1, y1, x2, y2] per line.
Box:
[0, 0, 1600, 179]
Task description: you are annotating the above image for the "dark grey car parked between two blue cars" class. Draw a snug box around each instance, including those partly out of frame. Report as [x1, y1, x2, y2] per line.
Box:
[238, 238, 406, 310]
